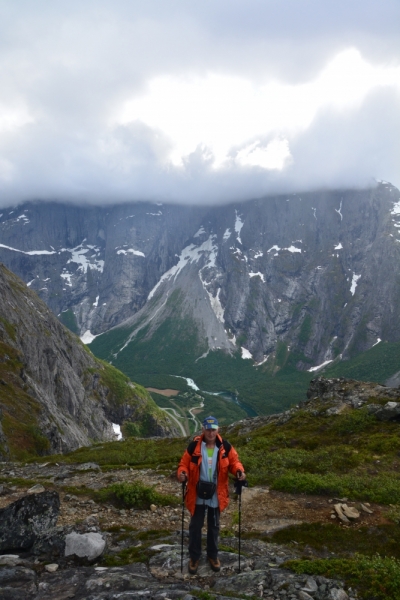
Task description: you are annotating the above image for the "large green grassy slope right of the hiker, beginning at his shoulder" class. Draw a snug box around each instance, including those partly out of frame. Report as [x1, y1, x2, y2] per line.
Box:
[230, 409, 400, 504]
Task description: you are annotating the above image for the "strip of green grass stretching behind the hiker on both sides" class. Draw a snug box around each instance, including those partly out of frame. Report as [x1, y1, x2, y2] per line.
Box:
[36, 398, 400, 505]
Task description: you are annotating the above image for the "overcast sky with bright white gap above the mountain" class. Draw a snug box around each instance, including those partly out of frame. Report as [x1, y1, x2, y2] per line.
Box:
[0, 0, 400, 206]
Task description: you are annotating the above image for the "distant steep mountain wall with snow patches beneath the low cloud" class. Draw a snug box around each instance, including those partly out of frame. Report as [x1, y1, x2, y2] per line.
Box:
[0, 182, 400, 413]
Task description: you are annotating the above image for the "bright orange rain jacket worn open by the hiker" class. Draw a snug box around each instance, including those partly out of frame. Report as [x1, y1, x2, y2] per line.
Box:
[177, 434, 244, 515]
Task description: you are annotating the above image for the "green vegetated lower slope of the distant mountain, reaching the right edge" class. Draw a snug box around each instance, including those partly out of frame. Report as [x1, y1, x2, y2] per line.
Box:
[90, 300, 400, 422]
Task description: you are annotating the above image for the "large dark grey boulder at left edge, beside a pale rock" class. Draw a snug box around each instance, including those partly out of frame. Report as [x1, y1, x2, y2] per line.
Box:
[0, 491, 60, 552]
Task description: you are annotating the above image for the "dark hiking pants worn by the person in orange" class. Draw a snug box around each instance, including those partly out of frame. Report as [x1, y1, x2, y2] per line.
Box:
[189, 504, 219, 561]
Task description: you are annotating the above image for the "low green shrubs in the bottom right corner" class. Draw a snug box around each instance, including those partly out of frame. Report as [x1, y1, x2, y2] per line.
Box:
[285, 554, 400, 600]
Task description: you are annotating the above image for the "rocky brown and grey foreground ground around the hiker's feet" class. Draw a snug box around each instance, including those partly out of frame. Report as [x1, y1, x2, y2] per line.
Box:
[0, 463, 386, 600]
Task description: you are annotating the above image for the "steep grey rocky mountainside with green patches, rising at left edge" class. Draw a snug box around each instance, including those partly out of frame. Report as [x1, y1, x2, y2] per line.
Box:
[0, 263, 176, 460]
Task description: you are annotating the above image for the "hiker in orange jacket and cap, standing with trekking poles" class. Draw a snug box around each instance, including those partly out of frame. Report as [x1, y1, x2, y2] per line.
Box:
[177, 416, 246, 575]
